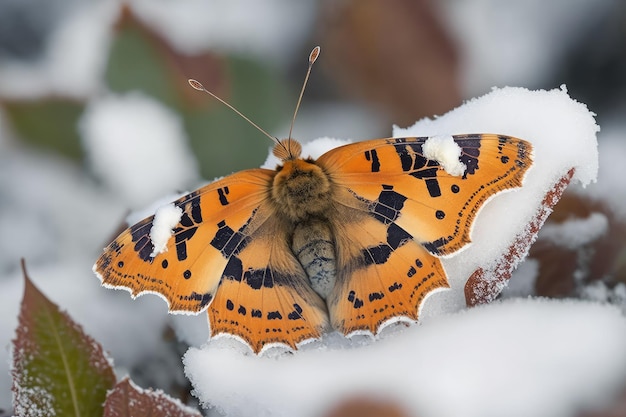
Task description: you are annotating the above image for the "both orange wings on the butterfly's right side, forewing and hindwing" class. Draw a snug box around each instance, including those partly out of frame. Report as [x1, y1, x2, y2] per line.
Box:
[317, 135, 532, 334]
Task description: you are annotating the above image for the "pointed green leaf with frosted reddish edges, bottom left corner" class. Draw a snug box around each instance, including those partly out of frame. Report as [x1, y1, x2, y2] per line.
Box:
[12, 261, 115, 417]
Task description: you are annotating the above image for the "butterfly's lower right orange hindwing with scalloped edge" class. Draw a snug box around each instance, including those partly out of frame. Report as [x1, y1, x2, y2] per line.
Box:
[327, 208, 448, 334]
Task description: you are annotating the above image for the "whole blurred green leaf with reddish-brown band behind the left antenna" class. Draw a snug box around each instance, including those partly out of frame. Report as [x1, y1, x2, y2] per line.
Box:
[105, 12, 286, 179]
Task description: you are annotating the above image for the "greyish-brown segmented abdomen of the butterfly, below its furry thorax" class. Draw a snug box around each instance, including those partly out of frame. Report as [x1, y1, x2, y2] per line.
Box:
[291, 218, 336, 299]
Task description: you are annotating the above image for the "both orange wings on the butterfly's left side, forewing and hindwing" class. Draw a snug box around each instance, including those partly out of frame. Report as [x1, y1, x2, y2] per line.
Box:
[94, 169, 327, 352]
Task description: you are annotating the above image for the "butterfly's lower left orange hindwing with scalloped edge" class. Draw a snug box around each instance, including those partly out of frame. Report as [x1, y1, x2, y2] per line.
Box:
[209, 207, 328, 353]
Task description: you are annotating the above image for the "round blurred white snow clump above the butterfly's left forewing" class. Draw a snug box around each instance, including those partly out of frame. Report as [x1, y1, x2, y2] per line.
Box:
[79, 92, 199, 208]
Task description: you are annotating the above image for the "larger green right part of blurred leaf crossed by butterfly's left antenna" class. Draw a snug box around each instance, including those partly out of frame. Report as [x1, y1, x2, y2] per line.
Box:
[182, 56, 286, 179]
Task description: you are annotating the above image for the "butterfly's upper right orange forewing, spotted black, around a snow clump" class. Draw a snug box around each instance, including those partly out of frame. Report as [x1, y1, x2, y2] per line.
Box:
[317, 134, 532, 256]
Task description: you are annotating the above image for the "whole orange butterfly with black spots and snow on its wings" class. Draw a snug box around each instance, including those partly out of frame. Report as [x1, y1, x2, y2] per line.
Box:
[94, 49, 532, 353]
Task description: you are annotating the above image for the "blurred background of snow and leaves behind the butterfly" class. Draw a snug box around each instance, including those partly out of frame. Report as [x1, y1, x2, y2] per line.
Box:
[0, 0, 626, 416]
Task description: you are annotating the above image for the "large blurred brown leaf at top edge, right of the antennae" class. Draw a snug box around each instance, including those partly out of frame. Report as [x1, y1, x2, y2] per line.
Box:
[319, 0, 461, 125]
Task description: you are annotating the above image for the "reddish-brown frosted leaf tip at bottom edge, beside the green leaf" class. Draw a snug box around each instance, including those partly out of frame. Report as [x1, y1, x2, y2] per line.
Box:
[104, 378, 202, 417]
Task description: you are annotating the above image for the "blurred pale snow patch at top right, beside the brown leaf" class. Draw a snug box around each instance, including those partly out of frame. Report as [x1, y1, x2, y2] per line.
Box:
[437, 0, 615, 97]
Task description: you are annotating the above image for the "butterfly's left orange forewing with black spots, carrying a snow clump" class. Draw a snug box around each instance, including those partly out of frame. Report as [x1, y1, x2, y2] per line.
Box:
[94, 169, 272, 313]
